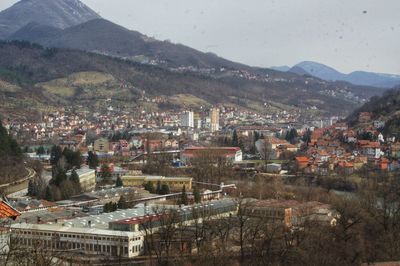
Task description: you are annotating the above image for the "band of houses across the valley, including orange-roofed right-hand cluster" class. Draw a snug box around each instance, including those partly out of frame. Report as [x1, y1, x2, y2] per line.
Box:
[3, 100, 399, 183]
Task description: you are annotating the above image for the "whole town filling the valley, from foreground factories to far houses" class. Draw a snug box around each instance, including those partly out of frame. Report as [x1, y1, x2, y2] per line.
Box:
[2, 93, 400, 261]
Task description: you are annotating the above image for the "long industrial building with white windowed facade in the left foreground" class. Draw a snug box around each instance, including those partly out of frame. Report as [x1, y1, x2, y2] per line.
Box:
[10, 199, 237, 258]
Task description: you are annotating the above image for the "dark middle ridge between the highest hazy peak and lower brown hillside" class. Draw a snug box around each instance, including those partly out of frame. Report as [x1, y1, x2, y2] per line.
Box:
[9, 18, 251, 69]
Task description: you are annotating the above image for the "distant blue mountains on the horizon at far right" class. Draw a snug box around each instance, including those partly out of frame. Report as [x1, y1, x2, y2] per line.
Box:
[272, 61, 400, 88]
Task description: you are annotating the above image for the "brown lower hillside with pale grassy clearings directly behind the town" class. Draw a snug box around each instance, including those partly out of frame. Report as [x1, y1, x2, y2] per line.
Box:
[0, 41, 384, 119]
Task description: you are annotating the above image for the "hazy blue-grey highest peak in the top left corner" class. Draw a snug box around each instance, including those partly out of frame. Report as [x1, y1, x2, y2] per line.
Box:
[0, 0, 100, 39]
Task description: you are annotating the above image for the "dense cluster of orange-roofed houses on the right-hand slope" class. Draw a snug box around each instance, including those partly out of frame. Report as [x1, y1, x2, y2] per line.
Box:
[295, 117, 400, 175]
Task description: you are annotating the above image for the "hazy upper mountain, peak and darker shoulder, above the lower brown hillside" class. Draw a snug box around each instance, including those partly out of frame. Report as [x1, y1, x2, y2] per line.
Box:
[0, 0, 250, 69]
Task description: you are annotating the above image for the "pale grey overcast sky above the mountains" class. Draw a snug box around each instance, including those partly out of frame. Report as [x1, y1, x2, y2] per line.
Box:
[0, 0, 400, 74]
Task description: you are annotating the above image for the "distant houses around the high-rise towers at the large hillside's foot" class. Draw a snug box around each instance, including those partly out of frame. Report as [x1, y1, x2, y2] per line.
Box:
[2, 96, 318, 148]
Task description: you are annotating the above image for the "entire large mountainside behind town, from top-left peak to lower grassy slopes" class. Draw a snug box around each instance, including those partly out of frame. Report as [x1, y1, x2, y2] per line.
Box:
[0, 0, 390, 119]
